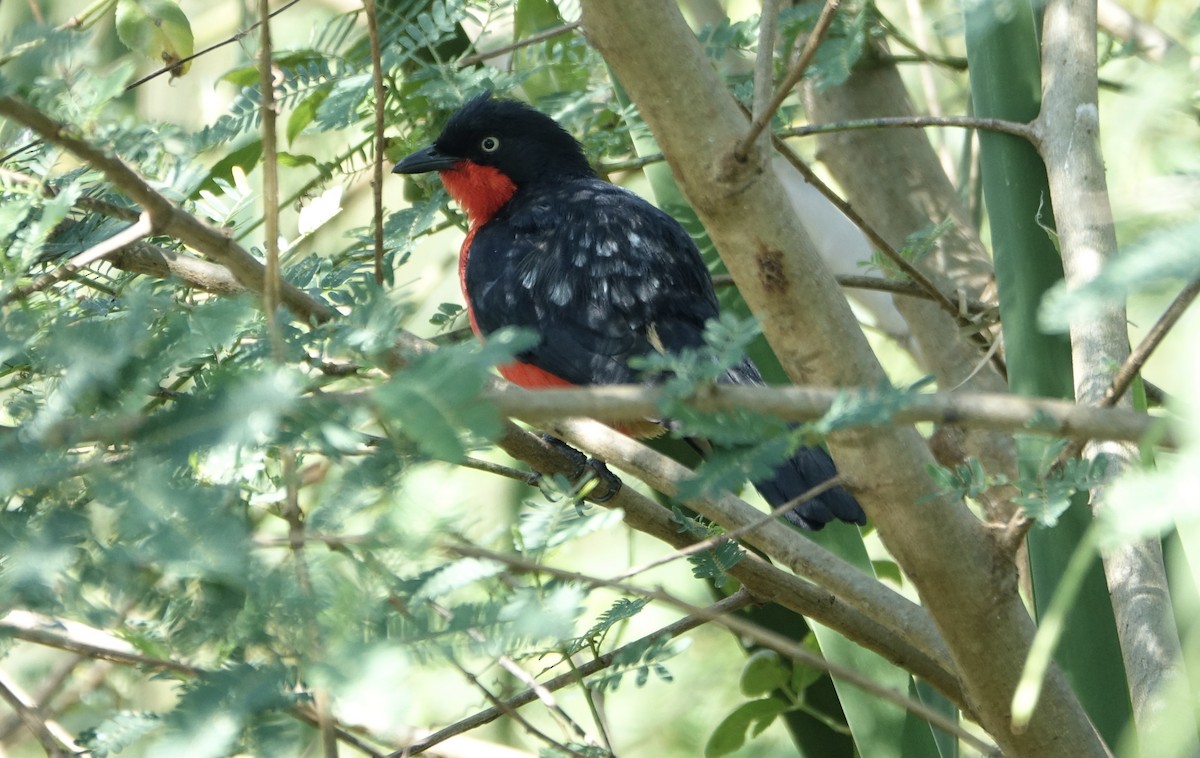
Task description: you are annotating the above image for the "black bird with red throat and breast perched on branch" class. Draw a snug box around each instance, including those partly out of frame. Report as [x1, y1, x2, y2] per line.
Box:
[392, 94, 866, 529]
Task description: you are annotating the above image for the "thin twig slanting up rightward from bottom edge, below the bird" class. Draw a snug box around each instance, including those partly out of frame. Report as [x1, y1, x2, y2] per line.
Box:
[390, 589, 754, 758]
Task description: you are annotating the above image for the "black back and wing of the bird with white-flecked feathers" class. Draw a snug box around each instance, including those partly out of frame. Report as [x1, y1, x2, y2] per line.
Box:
[466, 179, 718, 385]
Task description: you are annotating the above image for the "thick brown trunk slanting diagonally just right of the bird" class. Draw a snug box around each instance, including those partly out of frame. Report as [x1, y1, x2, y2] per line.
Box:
[583, 0, 1106, 756]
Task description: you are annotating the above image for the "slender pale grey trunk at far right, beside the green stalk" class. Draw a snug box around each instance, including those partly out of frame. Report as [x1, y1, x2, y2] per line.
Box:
[1037, 0, 1200, 754]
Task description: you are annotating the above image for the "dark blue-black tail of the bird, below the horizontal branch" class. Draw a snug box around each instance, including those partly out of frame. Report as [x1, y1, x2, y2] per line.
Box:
[726, 360, 866, 530]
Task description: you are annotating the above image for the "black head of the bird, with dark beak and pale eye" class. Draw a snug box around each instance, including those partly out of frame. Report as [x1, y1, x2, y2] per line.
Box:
[392, 92, 595, 188]
